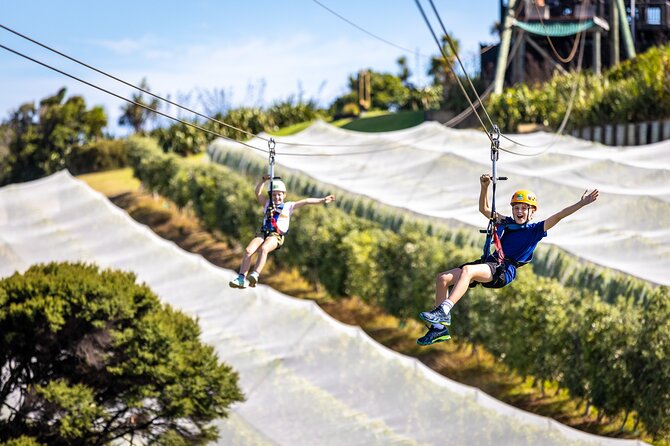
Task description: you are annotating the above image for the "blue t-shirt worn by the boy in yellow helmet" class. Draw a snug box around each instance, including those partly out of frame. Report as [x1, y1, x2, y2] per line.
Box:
[493, 217, 547, 283]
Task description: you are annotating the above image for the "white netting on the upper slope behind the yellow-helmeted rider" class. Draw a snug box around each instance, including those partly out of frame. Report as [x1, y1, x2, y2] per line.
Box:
[210, 122, 670, 285]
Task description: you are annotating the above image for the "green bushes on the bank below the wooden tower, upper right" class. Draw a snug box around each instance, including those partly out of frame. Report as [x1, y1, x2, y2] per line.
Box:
[487, 45, 670, 131]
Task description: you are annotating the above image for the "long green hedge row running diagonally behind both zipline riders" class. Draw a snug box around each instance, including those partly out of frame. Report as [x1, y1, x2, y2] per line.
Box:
[130, 139, 670, 435]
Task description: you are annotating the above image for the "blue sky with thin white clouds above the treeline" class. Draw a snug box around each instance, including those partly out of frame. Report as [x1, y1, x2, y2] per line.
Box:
[0, 0, 499, 134]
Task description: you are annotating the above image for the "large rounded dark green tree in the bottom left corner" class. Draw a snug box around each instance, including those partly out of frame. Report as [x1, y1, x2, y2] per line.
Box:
[0, 263, 243, 445]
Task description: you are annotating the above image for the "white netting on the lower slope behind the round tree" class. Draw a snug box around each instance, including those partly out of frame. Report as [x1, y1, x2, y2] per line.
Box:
[0, 173, 642, 446]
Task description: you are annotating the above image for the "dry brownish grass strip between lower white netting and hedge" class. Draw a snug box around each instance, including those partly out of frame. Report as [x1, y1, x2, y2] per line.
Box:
[79, 166, 656, 446]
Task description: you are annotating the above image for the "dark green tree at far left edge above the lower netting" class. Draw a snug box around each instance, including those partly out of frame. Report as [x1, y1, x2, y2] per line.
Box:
[0, 88, 107, 184]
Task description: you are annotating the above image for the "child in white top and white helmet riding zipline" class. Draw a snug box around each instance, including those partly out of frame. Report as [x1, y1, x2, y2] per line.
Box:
[229, 175, 335, 288]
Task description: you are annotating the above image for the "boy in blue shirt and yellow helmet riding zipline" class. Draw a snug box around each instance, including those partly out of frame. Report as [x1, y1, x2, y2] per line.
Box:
[416, 174, 598, 345]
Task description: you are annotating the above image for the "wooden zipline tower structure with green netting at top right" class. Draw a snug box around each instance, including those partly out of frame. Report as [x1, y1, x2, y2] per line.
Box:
[481, 0, 670, 92]
